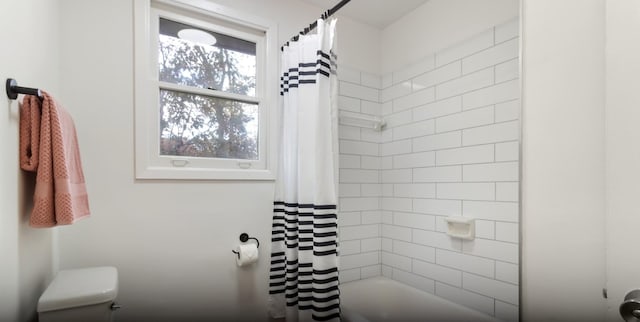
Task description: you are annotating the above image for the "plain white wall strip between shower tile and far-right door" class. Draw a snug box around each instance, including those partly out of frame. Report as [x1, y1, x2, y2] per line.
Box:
[521, 0, 605, 321]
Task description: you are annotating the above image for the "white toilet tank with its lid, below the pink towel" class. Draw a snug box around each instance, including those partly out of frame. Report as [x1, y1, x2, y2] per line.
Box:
[38, 266, 119, 322]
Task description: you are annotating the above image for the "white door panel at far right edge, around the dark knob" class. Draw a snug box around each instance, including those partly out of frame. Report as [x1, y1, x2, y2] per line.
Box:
[605, 0, 640, 321]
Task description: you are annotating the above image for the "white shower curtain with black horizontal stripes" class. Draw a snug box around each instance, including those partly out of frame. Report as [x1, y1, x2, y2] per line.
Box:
[269, 19, 340, 322]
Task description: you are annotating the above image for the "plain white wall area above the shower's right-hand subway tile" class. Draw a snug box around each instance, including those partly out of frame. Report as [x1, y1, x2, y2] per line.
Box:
[380, 0, 519, 74]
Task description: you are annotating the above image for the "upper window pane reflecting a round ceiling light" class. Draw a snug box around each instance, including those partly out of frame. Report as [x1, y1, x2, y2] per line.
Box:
[158, 18, 256, 96]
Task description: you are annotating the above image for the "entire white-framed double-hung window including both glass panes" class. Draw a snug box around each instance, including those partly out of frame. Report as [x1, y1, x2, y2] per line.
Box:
[135, 1, 277, 180]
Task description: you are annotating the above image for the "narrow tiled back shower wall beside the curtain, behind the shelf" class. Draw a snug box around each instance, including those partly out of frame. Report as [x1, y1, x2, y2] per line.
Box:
[338, 65, 382, 283]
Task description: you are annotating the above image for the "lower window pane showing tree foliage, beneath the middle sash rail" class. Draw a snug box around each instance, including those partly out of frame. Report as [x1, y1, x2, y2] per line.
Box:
[160, 90, 258, 160]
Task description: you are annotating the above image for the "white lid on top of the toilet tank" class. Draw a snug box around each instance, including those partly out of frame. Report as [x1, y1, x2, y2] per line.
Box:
[38, 266, 118, 312]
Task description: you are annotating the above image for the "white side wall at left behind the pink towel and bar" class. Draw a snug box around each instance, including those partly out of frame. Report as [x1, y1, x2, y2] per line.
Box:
[0, 0, 60, 321]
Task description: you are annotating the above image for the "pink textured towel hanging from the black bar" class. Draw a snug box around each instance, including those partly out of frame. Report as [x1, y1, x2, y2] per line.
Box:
[20, 92, 90, 227]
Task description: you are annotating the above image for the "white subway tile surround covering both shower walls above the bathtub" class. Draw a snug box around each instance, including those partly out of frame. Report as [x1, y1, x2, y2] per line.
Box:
[338, 20, 520, 321]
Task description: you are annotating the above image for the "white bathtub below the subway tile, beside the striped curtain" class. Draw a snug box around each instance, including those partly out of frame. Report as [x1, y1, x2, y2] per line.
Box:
[340, 277, 497, 322]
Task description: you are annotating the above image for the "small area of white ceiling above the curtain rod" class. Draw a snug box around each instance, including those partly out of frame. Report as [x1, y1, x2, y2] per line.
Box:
[301, 0, 429, 29]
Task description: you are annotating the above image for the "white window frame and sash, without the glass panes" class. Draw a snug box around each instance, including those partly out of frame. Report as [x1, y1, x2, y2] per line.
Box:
[134, 0, 278, 180]
